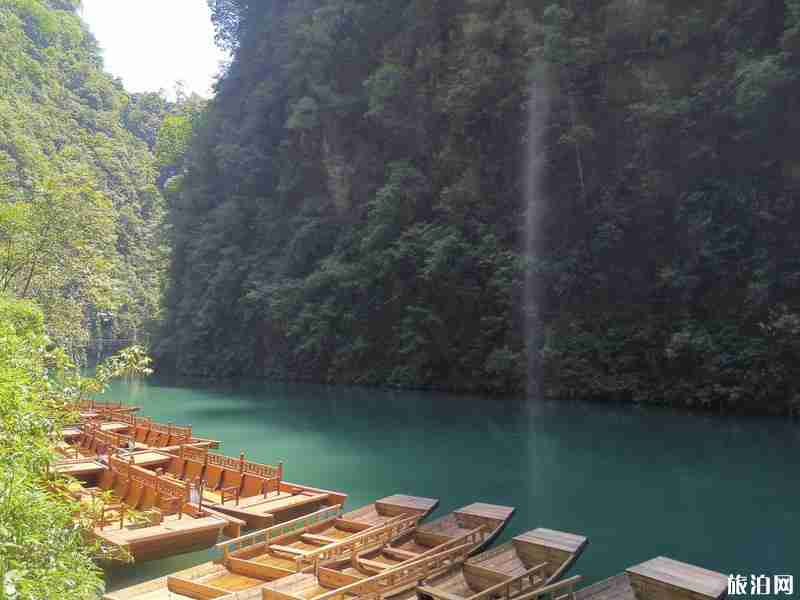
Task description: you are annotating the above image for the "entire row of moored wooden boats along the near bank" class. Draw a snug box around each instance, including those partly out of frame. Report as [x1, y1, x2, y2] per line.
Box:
[56, 402, 727, 600]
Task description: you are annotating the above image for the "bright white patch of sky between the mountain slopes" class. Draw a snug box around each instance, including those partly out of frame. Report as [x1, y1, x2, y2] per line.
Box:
[82, 0, 227, 97]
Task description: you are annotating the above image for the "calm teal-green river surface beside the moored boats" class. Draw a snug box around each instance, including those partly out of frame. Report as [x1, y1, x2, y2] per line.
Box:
[107, 380, 800, 590]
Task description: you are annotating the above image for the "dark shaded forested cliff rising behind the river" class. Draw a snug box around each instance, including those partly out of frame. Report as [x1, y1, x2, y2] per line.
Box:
[157, 0, 800, 410]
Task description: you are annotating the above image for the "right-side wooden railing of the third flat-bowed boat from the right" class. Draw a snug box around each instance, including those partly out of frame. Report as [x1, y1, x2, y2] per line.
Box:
[310, 544, 475, 600]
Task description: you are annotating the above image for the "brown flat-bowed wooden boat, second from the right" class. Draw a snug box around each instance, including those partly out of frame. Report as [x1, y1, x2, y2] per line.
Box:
[417, 528, 587, 600]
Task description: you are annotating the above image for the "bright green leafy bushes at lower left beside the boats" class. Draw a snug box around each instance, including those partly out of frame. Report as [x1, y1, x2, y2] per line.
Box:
[0, 297, 102, 600]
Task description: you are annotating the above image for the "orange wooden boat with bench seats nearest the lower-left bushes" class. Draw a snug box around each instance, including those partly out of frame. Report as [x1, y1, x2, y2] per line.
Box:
[67, 455, 243, 562]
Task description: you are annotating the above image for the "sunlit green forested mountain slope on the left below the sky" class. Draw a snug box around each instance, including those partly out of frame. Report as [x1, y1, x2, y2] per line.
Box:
[0, 0, 166, 352]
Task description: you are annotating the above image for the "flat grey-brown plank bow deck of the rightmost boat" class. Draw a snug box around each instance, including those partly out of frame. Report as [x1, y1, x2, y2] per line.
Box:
[626, 556, 728, 598]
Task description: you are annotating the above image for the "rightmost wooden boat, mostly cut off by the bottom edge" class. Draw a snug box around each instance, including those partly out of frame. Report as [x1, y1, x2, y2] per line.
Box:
[572, 556, 728, 600]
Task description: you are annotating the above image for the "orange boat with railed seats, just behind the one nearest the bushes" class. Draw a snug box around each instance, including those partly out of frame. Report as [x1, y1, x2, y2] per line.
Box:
[158, 445, 347, 529]
